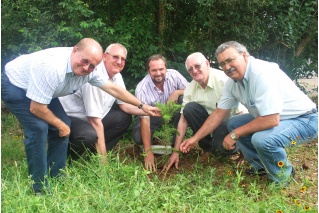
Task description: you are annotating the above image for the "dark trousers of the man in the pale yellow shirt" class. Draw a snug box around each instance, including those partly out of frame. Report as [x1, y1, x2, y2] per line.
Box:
[183, 102, 237, 155]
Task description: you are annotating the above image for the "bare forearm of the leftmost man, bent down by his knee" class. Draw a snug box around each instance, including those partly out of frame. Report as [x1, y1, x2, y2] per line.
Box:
[30, 100, 70, 137]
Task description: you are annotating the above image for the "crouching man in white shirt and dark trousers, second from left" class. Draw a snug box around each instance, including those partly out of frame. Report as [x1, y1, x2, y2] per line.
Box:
[60, 43, 156, 160]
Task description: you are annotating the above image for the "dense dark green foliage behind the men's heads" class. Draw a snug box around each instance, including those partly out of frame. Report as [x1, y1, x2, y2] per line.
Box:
[1, 0, 318, 89]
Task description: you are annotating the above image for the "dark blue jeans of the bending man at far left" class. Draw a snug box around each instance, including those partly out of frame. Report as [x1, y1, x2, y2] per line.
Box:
[1, 73, 71, 192]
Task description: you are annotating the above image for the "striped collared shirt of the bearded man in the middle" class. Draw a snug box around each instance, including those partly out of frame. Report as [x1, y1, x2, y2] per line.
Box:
[135, 69, 188, 106]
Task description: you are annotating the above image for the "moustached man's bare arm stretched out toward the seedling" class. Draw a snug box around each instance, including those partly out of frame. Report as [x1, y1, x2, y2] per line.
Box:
[180, 108, 230, 153]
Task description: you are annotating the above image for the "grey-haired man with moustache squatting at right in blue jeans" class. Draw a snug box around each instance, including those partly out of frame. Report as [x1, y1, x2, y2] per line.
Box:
[180, 41, 318, 184]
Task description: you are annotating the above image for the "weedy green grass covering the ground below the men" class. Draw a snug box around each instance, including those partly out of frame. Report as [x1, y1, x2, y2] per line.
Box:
[1, 110, 318, 213]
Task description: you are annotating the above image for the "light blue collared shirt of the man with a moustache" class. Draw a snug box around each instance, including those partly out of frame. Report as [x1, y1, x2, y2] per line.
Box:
[218, 56, 316, 120]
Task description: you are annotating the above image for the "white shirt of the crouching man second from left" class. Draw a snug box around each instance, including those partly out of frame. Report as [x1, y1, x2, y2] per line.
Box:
[59, 62, 126, 121]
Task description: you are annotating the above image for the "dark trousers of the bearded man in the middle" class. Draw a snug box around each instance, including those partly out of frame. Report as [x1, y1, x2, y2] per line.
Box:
[133, 95, 183, 146]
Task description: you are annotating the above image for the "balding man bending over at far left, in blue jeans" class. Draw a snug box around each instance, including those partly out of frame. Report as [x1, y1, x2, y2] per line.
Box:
[1, 38, 157, 195]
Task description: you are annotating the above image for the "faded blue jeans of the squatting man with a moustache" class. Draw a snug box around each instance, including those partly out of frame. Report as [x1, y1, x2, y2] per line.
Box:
[227, 112, 318, 183]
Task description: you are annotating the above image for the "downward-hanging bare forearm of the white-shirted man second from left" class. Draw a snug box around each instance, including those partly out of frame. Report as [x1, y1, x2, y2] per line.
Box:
[88, 117, 106, 156]
